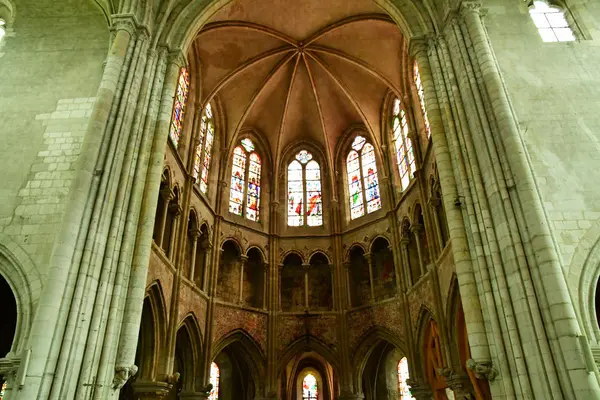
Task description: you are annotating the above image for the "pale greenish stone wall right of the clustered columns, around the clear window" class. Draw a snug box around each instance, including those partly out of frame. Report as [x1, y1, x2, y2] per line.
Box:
[485, 0, 600, 270]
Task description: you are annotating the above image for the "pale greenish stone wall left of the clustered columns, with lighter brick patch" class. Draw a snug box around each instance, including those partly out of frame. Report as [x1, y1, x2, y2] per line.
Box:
[0, 0, 109, 281]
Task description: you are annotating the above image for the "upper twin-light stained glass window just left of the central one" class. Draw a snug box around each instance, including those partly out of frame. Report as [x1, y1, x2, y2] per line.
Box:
[229, 139, 261, 221]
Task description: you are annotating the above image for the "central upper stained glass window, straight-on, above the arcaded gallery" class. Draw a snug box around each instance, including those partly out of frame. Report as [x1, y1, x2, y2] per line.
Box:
[288, 150, 323, 226]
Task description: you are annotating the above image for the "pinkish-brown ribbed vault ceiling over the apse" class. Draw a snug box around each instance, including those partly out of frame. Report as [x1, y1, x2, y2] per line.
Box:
[193, 0, 403, 167]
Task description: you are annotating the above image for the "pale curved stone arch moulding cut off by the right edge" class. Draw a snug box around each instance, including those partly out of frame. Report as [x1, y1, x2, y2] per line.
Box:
[567, 221, 600, 344]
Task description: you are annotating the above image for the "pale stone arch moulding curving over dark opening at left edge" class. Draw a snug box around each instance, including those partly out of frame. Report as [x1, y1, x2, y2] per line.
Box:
[0, 234, 42, 353]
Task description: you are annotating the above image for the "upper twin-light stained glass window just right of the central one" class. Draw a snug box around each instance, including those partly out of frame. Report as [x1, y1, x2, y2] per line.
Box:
[346, 136, 381, 219]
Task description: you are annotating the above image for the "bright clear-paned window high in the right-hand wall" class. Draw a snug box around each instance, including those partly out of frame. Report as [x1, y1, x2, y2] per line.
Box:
[529, 1, 575, 42]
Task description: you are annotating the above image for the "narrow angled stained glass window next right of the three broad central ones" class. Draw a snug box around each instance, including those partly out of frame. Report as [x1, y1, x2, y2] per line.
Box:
[392, 99, 415, 190]
